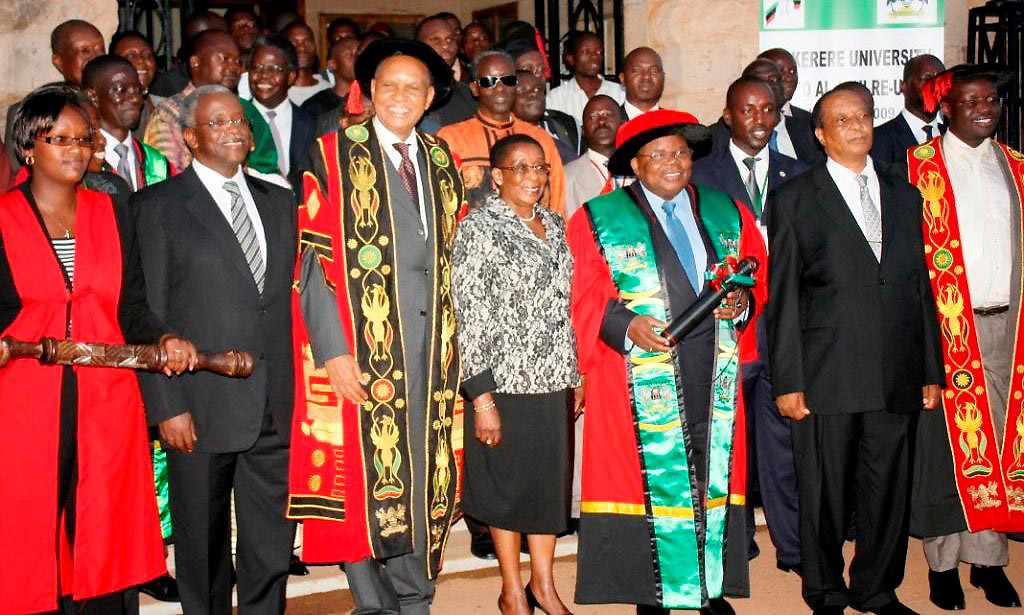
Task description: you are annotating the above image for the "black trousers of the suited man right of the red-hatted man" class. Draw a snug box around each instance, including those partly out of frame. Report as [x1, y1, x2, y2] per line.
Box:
[793, 407, 918, 611]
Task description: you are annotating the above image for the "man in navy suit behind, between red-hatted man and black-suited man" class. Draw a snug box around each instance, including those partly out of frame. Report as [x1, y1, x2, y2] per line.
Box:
[693, 77, 807, 570]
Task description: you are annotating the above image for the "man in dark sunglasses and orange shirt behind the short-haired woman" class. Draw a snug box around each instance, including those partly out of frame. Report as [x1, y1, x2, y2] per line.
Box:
[437, 49, 565, 216]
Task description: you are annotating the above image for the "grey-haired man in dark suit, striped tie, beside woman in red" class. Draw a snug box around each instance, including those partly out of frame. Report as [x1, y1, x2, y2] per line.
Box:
[133, 85, 297, 615]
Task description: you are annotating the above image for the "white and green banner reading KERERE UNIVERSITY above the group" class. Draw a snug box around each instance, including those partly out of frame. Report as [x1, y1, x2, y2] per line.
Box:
[760, 0, 945, 124]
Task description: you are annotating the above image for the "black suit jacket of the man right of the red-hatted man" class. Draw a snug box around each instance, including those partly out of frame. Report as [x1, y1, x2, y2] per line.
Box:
[766, 164, 944, 414]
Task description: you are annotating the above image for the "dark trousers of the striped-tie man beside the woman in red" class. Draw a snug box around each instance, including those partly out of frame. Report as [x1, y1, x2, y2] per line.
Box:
[167, 412, 295, 615]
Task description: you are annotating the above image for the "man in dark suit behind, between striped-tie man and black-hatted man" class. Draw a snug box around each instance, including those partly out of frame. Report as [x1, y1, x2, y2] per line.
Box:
[249, 34, 316, 191]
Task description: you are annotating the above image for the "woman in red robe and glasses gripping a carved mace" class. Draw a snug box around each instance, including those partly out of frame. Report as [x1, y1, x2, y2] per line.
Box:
[0, 85, 196, 613]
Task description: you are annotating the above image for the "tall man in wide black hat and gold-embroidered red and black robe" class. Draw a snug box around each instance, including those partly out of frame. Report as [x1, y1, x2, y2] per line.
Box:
[288, 39, 464, 615]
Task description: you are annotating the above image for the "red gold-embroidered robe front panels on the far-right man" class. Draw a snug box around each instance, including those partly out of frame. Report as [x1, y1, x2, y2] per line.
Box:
[907, 137, 1024, 532]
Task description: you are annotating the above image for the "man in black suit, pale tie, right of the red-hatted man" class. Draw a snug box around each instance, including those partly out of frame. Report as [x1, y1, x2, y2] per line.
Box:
[766, 90, 944, 615]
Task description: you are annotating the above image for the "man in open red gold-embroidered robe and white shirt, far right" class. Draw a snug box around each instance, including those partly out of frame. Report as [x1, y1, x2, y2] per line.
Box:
[906, 64, 1024, 610]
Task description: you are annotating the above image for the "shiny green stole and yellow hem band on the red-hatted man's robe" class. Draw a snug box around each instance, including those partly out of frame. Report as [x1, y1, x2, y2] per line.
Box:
[584, 186, 743, 609]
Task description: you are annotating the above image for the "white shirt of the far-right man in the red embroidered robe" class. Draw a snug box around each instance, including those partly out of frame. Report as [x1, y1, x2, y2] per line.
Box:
[942, 131, 1013, 308]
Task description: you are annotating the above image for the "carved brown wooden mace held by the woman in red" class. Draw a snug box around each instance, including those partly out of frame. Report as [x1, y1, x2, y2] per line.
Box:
[0, 338, 253, 378]
